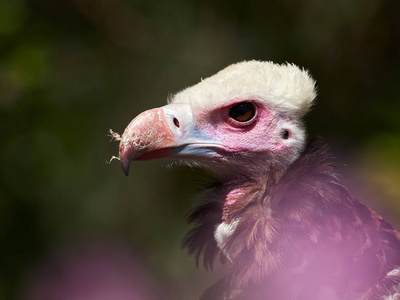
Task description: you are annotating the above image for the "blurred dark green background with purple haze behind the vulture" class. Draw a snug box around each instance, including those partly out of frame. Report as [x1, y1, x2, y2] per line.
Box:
[0, 0, 400, 300]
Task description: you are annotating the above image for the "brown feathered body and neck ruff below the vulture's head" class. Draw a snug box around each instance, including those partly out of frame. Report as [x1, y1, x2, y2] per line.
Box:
[184, 142, 400, 300]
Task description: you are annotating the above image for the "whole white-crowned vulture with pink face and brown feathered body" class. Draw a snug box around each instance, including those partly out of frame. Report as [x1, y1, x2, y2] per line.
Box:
[111, 61, 400, 300]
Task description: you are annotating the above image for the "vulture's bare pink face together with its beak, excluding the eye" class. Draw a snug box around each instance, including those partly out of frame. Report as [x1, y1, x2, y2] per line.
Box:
[112, 99, 292, 175]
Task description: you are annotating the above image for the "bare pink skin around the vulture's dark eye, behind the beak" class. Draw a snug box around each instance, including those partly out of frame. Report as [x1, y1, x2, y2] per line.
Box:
[196, 100, 286, 157]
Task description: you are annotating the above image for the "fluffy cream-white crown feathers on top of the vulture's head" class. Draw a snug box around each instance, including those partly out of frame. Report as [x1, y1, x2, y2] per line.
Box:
[171, 61, 316, 118]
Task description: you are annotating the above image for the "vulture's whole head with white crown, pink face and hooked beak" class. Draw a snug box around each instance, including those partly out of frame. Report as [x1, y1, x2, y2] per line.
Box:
[118, 61, 316, 176]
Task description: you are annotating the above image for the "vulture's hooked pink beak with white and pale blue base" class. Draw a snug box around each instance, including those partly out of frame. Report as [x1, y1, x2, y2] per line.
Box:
[115, 104, 221, 175]
